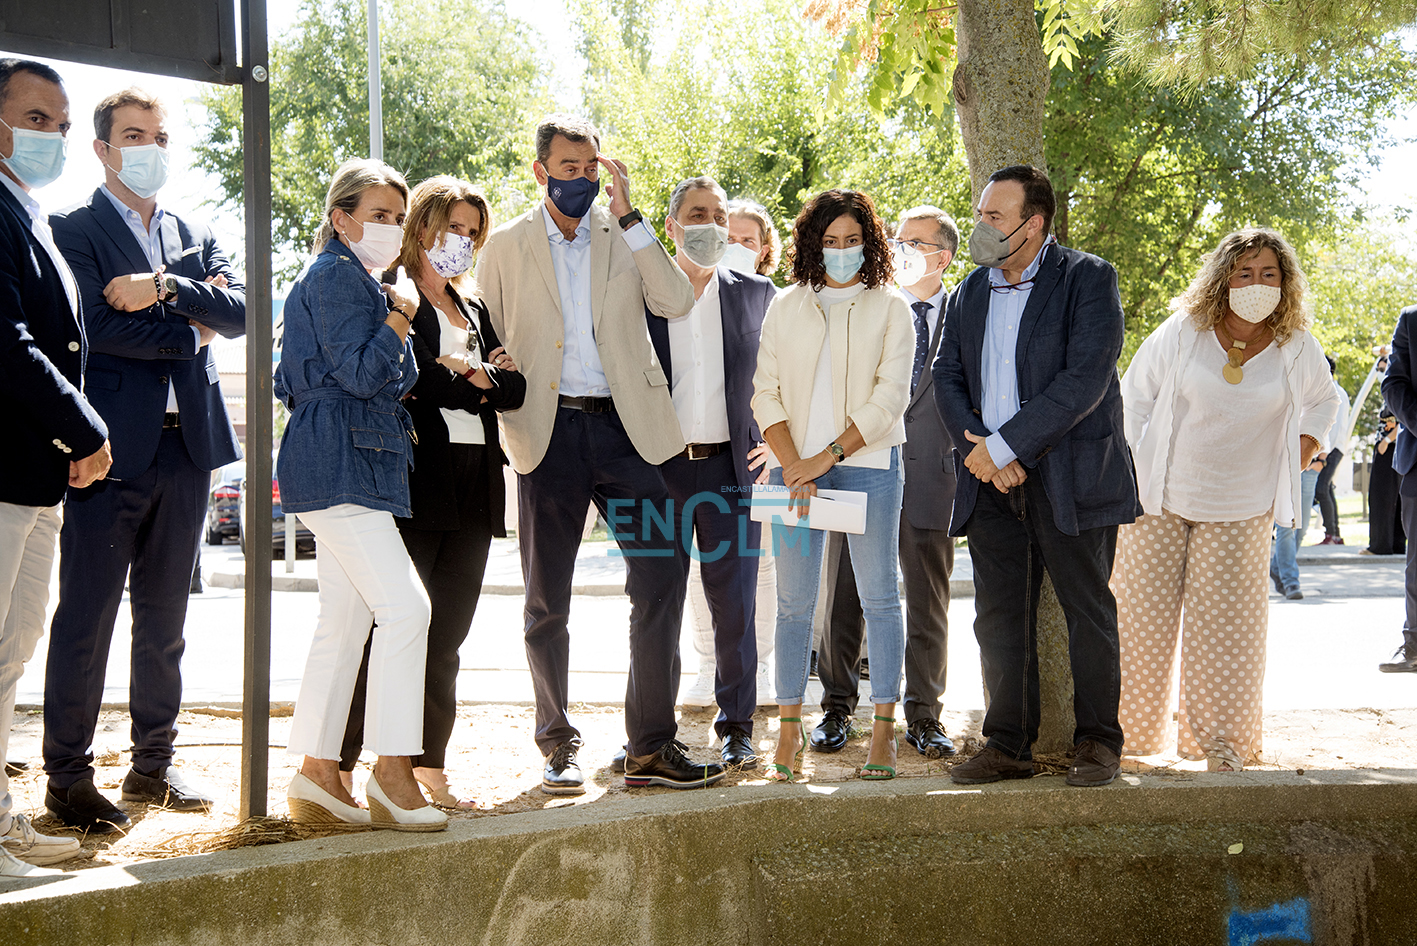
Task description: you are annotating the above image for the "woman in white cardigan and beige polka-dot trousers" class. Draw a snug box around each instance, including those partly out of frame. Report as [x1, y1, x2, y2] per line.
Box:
[1112, 229, 1338, 772]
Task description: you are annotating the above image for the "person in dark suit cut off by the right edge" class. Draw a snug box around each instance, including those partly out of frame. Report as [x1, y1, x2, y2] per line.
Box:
[1377, 306, 1417, 673]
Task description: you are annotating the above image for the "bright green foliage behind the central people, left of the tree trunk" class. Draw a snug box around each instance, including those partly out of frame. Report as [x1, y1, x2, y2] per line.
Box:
[578, 0, 969, 273]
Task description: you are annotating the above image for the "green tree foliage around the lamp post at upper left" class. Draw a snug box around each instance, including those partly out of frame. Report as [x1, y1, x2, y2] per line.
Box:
[196, 0, 548, 279]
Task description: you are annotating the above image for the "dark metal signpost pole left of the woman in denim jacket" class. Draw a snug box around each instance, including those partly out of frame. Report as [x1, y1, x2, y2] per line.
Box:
[241, 0, 272, 819]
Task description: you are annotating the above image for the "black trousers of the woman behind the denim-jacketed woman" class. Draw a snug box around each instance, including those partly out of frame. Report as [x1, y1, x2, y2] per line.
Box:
[340, 443, 492, 772]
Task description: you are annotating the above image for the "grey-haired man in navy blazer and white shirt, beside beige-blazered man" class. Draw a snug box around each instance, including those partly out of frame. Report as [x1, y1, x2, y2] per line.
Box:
[645, 177, 777, 769]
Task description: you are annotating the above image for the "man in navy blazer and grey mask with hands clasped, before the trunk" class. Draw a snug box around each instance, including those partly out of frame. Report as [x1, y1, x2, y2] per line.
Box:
[934, 166, 1141, 786]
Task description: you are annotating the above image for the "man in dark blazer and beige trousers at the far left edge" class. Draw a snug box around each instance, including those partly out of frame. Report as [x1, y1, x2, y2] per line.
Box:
[0, 59, 112, 878]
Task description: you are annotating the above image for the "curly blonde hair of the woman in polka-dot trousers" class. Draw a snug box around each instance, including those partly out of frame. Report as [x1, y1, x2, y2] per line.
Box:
[1170, 227, 1312, 346]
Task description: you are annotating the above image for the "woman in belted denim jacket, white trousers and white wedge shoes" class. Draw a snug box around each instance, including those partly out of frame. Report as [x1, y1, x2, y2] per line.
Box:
[275, 160, 448, 831]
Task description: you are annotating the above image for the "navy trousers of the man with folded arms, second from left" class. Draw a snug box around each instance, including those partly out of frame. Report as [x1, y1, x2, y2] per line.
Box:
[44, 428, 210, 789]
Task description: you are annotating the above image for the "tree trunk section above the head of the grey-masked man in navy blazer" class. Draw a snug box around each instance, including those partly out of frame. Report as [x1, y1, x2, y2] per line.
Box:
[954, 0, 1049, 201]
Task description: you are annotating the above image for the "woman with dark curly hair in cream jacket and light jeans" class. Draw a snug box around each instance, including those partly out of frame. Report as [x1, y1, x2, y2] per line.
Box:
[752, 190, 915, 782]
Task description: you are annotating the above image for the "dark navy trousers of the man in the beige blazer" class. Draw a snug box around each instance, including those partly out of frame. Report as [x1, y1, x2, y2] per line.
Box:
[517, 408, 687, 755]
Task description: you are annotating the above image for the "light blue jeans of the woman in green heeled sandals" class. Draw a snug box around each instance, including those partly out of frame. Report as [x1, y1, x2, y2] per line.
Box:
[771, 448, 905, 707]
